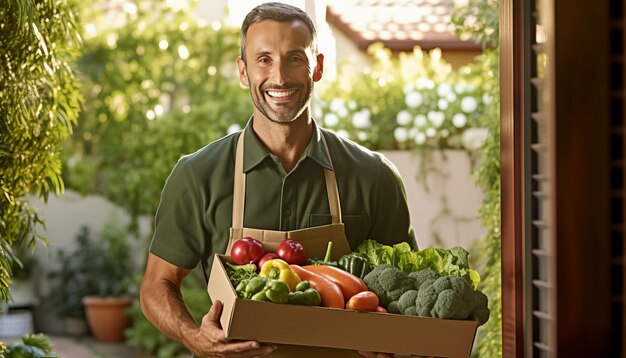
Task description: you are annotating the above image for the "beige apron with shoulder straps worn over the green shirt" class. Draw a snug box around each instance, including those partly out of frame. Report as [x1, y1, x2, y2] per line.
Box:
[226, 133, 361, 358]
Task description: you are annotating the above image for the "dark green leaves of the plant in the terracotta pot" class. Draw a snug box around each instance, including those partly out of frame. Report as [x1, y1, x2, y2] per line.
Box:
[49, 222, 132, 317]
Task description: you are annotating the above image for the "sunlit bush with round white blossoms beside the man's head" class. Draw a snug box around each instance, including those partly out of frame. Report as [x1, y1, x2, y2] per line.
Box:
[313, 44, 491, 150]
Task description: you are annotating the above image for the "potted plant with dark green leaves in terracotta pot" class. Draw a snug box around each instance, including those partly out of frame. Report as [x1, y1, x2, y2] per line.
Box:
[52, 222, 132, 342]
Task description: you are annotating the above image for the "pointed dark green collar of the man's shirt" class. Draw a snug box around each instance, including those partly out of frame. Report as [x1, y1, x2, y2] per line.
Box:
[243, 118, 333, 173]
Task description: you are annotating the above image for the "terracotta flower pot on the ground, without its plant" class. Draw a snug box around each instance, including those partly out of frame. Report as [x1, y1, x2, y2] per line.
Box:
[83, 296, 132, 342]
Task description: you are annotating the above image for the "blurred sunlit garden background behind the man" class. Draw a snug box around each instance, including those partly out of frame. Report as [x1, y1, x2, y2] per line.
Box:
[0, 0, 501, 357]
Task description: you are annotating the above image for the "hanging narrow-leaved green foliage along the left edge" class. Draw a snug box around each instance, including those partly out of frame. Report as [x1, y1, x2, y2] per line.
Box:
[0, 0, 81, 300]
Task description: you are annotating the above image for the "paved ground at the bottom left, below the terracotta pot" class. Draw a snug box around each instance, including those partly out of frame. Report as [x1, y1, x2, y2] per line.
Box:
[0, 336, 145, 358]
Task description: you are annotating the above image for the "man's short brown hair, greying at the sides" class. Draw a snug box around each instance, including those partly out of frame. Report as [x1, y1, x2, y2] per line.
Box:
[239, 2, 317, 63]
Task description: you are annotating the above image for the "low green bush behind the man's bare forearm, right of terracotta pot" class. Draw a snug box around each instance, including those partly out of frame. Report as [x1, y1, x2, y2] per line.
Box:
[125, 271, 211, 358]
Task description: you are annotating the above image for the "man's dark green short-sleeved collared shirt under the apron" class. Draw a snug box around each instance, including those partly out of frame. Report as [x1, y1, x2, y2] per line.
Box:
[150, 120, 417, 269]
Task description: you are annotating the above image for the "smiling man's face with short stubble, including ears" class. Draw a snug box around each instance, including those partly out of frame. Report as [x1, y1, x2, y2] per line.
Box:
[237, 20, 324, 123]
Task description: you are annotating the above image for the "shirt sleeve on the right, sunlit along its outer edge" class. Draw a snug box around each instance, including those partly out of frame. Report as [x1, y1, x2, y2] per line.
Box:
[370, 154, 417, 249]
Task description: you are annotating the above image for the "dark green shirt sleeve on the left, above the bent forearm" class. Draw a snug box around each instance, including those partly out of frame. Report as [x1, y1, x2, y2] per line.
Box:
[150, 157, 207, 269]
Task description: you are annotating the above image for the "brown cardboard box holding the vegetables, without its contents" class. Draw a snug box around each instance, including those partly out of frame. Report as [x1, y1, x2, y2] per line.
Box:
[208, 255, 478, 357]
